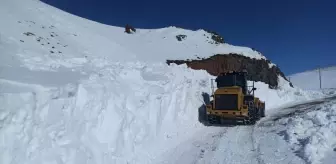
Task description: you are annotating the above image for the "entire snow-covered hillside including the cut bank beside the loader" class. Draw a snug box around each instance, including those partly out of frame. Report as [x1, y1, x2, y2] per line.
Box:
[0, 0, 330, 164]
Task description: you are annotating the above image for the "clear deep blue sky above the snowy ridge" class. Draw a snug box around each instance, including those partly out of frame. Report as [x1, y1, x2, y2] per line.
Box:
[42, 0, 336, 75]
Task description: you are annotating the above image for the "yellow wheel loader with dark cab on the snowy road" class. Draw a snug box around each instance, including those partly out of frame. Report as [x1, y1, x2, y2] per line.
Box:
[206, 71, 265, 125]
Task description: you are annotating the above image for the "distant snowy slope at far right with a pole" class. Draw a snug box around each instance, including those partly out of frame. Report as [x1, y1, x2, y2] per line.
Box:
[288, 67, 336, 90]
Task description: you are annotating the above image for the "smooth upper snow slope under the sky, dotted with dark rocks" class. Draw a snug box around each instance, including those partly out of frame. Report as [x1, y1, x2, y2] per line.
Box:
[0, 0, 266, 69]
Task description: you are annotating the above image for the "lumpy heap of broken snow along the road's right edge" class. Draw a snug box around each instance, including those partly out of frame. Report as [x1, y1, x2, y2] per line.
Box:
[283, 101, 336, 163]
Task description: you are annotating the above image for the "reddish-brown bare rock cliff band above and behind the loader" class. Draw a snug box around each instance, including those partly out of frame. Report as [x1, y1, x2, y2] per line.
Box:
[166, 54, 293, 89]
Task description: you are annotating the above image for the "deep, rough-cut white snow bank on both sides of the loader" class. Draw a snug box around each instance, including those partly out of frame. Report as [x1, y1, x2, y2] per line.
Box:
[0, 63, 326, 164]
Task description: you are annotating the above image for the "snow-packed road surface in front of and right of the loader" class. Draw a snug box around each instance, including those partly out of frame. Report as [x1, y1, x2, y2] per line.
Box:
[158, 97, 336, 164]
